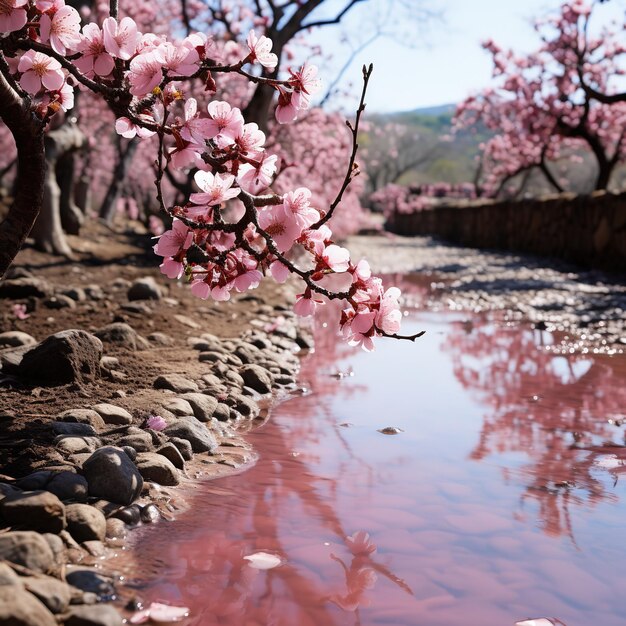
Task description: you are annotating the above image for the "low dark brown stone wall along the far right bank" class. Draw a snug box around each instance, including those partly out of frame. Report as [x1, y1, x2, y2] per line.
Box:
[385, 192, 626, 273]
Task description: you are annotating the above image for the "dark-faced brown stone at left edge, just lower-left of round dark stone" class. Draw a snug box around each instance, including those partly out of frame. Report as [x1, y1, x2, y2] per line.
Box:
[0, 491, 66, 533]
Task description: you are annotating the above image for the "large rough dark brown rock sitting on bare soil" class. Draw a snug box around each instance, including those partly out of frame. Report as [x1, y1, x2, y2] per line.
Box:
[18, 330, 102, 384]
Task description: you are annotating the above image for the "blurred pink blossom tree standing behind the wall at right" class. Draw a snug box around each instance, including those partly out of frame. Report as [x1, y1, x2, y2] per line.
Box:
[456, 0, 626, 196]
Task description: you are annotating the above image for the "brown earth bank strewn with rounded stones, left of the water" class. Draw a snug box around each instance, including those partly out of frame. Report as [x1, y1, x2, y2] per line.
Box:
[0, 225, 312, 626]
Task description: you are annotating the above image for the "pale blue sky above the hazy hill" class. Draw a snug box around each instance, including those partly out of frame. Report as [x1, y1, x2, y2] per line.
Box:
[314, 0, 626, 112]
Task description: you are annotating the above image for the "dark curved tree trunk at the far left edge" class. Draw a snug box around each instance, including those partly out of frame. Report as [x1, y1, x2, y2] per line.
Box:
[0, 73, 46, 278]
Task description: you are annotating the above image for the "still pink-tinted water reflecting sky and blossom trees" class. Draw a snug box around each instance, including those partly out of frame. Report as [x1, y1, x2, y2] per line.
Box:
[124, 280, 626, 626]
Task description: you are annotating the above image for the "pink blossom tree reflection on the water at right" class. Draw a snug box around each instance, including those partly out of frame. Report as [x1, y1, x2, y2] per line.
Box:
[445, 317, 626, 539]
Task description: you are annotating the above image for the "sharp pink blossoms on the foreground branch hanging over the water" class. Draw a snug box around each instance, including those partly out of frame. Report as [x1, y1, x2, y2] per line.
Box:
[0, 0, 401, 350]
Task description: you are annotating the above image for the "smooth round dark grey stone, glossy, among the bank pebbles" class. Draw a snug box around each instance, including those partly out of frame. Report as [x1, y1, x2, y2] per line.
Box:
[83, 446, 143, 504]
